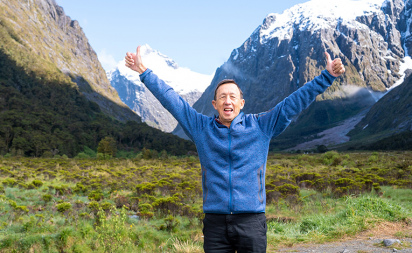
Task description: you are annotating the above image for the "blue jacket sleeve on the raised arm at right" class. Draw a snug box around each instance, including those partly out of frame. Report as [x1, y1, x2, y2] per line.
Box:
[257, 70, 335, 138]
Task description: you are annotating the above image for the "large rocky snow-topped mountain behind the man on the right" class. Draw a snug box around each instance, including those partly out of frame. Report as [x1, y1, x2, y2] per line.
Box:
[174, 0, 412, 149]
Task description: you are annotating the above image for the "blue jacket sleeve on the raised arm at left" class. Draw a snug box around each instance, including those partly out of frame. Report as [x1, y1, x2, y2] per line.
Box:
[140, 69, 207, 141]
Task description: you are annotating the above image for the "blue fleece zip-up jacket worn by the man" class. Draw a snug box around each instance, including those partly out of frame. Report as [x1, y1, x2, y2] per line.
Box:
[140, 69, 335, 214]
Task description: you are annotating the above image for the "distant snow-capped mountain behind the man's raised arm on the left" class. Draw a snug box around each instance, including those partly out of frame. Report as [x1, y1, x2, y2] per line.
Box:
[107, 45, 212, 132]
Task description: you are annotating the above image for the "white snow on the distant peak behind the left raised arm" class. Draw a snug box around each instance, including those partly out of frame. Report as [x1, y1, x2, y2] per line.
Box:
[117, 44, 213, 95]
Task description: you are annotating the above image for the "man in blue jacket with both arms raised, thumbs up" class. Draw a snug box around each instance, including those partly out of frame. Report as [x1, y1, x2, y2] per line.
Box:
[125, 46, 345, 253]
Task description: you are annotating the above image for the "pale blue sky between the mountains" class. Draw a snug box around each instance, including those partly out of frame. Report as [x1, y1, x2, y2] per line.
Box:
[56, 0, 307, 74]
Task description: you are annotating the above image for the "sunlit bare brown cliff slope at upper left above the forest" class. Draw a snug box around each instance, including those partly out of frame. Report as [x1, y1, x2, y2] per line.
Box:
[0, 0, 140, 121]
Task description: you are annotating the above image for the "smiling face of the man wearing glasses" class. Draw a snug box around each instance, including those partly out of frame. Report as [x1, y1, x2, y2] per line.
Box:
[212, 83, 245, 127]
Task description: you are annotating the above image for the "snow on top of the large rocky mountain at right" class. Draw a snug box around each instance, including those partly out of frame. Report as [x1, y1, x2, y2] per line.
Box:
[260, 0, 387, 44]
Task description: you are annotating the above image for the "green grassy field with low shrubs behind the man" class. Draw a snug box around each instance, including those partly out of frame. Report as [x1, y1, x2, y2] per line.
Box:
[0, 151, 412, 252]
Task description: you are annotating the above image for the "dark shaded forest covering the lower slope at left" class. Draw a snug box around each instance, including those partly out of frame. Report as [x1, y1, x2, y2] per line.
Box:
[0, 30, 195, 157]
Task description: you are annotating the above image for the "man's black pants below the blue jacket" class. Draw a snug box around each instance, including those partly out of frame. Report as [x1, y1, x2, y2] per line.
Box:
[203, 213, 267, 253]
